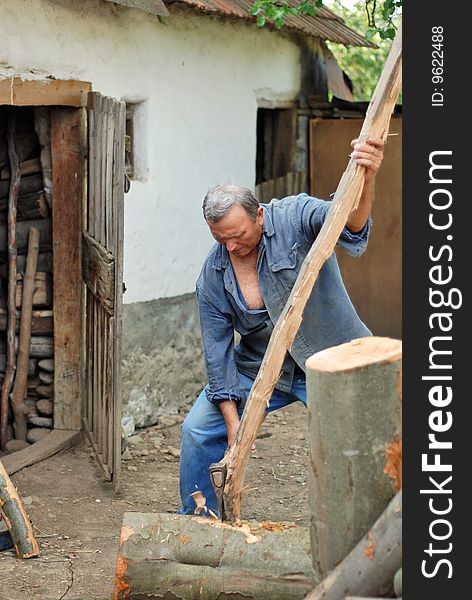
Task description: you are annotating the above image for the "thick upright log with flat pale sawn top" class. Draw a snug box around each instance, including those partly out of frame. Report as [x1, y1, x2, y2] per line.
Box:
[306, 337, 402, 579]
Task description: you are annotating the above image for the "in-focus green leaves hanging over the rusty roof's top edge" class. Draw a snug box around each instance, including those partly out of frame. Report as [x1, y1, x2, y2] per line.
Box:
[249, 0, 402, 39]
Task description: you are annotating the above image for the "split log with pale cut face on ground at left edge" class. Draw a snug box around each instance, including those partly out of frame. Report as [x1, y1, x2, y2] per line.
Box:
[0, 460, 39, 558]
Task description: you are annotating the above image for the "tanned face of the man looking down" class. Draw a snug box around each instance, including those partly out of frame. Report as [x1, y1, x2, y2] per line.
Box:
[207, 204, 264, 258]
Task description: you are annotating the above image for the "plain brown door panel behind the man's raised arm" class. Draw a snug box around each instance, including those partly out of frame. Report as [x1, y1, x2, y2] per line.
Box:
[310, 117, 402, 338]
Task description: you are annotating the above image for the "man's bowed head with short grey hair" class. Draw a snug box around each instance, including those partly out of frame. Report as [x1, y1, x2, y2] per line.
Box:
[203, 184, 264, 258]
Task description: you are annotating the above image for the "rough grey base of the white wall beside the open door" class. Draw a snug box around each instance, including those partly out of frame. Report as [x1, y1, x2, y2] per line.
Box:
[123, 293, 206, 427]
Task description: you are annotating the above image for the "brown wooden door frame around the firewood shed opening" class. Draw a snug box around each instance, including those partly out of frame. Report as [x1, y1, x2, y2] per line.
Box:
[0, 77, 125, 482]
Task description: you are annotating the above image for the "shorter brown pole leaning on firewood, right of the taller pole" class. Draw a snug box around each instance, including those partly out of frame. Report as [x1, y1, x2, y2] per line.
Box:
[11, 227, 39, 440]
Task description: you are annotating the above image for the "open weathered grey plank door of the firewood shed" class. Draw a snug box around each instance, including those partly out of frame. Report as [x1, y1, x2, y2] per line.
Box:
[82, 92, 126, 489]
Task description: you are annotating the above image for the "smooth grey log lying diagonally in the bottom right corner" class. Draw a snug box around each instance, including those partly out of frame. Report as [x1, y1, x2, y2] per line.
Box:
[306, 491, 402, 600]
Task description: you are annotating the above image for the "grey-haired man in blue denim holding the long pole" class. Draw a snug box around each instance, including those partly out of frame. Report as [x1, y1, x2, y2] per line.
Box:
[180, 139, 384, 514]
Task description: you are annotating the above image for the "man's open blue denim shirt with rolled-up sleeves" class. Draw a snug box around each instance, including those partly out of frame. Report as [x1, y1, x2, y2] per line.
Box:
[196, 194, 371, 403]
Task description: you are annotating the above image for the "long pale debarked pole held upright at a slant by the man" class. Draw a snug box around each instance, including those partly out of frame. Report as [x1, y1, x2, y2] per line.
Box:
[214, 25, 402, 522]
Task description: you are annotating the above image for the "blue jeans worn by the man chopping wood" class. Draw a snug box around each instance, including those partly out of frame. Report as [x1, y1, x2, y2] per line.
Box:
[179, 373, 306, 515]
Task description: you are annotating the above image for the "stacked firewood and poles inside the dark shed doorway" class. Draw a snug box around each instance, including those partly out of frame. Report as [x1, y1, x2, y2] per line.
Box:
[0, 107, 54, 451]
